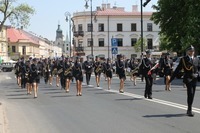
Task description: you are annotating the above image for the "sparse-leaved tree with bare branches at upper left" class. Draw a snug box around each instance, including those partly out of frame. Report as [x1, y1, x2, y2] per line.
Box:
[0, 0, 35, 31]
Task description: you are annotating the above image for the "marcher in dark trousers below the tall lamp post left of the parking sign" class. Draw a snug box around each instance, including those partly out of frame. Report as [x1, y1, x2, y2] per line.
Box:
[83, 56, 93, 85]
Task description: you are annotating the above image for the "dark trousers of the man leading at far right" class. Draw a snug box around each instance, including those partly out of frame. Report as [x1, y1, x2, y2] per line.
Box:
[186, 81, 196, 111]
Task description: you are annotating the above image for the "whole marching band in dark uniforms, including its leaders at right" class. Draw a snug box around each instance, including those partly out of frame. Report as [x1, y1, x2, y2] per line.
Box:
[15, 46, 199, 116]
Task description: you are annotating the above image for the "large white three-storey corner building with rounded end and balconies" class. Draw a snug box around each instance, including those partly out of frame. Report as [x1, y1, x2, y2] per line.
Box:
[72, 4, 160, 58]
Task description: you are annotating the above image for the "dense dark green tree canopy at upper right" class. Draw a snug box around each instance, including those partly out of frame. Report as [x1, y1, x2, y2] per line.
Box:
[151, 0, 200, 54]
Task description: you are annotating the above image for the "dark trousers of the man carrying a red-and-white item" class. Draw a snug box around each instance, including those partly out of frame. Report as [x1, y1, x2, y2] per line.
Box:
[145, 76, 153, 96]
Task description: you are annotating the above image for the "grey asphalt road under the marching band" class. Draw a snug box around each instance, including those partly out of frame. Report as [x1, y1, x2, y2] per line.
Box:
[0, 72, 200, 133]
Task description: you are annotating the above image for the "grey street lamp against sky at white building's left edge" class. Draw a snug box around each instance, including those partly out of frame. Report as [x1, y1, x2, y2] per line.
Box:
[65, 12, 72, 57]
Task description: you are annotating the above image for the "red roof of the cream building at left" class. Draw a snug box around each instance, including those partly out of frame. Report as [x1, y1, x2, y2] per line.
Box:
[7, 28, 39, 45]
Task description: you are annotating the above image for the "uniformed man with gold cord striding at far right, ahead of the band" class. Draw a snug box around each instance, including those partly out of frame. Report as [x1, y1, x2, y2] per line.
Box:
[170, 46, 198, 117]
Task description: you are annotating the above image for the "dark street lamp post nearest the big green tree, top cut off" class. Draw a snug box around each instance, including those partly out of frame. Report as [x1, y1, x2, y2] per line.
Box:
[140, 0, 151, 54]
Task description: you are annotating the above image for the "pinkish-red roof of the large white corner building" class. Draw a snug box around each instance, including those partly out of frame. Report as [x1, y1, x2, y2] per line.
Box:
[96, 8, 153, 16]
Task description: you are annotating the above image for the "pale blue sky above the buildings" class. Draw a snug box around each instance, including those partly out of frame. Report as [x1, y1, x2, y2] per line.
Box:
[12, 0, 158, 41]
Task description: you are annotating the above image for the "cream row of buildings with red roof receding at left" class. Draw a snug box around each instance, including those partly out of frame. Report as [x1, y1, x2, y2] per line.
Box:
[6, 26, 62, 61]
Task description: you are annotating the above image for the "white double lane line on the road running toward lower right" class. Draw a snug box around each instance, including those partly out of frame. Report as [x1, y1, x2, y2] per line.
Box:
[105, 90, 200, 114]
